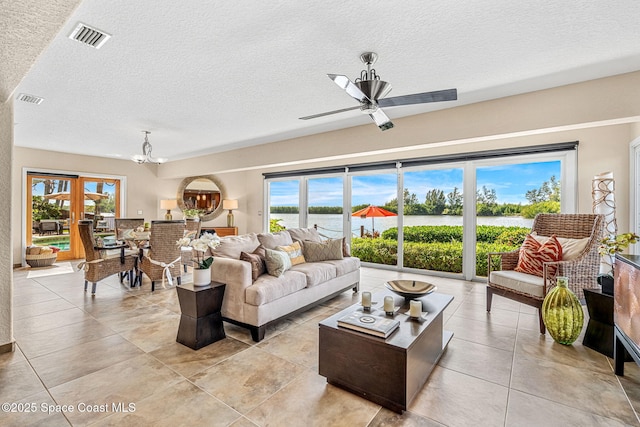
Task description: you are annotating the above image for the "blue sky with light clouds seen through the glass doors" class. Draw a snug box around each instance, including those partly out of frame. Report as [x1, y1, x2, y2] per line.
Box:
[270, 161, 561, 206]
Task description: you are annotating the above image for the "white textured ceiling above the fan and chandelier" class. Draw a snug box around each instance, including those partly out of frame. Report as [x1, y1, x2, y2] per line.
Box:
[10, 0, 640, 160]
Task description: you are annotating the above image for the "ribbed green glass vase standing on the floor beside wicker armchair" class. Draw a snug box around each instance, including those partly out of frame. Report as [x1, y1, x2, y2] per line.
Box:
[542, 277, 584, 345]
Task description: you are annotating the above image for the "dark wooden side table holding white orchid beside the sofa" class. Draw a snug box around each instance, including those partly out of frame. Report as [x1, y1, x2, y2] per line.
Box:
[176, 282, 226, 350]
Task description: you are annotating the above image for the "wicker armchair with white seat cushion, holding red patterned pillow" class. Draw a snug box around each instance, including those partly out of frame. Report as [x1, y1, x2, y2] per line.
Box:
[487, 214, 604, 334]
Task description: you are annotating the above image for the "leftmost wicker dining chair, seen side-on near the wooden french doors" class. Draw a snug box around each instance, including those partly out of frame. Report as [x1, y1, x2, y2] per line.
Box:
[78, 220, 138, 295]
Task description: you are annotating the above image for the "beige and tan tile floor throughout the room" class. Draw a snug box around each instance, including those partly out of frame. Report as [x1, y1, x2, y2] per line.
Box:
[0, 268, 640, 427]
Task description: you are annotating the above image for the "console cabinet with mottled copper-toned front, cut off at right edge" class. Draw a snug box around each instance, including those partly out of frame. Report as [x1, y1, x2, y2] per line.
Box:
[613, 254, 640, 375]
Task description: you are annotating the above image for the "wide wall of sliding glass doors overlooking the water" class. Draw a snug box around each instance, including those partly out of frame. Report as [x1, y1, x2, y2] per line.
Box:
[265, 142, 577, 280]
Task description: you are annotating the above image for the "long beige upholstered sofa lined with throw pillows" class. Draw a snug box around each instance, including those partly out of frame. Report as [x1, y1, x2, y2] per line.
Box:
[211, 229, 360, 342]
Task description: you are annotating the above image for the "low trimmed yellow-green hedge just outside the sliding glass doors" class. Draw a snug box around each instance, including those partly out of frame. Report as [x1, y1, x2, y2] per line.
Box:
[351, 233, 520, 276]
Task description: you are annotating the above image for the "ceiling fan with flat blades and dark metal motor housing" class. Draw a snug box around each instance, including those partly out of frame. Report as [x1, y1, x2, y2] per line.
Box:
[300, 52, 458, 130]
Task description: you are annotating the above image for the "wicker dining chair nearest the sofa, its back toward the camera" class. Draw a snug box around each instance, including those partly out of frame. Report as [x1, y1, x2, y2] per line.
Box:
[139, 220, 185, 291]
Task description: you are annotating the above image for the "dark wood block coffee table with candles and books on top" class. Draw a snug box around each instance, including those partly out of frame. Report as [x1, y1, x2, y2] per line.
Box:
[319, 291, 453, 413]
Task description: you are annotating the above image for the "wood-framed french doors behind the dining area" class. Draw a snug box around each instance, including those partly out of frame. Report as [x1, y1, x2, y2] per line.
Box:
[25, 172, 120, 260]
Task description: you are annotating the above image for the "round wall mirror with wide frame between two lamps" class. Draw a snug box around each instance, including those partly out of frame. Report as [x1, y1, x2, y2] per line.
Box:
[176, 175, 226, 221]
